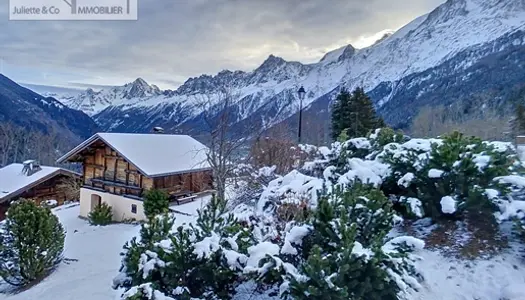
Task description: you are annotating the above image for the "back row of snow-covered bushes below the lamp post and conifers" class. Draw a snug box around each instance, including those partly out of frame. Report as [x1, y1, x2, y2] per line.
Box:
[296, 128, 521, 224]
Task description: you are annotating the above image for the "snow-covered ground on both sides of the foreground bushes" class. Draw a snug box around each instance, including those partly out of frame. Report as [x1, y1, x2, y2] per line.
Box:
[0, 198, 525, 300]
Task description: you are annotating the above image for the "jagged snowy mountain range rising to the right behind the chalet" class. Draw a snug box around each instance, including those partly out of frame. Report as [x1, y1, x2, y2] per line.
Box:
[56, 0, 525, 136]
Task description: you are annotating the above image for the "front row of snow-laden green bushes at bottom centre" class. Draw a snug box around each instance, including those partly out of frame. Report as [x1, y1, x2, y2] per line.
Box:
[114, 180, 423, 299]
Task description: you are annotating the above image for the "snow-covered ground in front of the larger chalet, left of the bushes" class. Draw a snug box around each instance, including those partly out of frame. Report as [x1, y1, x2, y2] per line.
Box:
[0, 198, 208, 300]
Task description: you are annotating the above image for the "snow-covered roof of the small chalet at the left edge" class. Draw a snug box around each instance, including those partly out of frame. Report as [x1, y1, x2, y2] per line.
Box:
[0, 163, 76, 201]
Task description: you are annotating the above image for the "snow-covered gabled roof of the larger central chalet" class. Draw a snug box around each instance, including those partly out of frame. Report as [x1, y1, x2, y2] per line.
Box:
[58, 133, 210, 177]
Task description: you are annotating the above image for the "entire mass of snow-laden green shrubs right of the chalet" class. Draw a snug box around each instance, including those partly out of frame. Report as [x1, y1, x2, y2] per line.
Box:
[115, 129, 525, 300]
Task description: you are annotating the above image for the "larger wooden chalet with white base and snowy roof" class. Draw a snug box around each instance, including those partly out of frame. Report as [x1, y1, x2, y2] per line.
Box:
[58, 133, 213, 221]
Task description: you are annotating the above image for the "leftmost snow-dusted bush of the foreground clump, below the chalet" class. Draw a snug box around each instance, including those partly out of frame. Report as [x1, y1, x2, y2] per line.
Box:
[113, 199, 250, 299]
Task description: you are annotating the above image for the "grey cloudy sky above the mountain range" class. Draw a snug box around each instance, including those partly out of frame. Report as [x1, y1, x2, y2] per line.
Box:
[0, 0, 444, 88]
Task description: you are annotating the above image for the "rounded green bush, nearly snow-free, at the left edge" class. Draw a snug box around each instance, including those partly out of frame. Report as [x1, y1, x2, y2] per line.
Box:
[0, 200, 65, 286]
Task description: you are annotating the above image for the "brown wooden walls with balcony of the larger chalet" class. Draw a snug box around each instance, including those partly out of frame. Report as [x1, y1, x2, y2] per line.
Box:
[79, 140, 212, 198]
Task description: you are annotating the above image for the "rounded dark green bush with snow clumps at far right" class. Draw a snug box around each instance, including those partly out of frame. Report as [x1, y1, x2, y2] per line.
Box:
[381, 132, 517, 219]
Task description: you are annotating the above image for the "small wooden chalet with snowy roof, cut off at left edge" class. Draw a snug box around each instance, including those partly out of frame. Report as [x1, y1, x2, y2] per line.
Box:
[0, 160, 81, 219]
